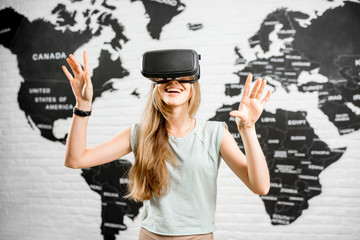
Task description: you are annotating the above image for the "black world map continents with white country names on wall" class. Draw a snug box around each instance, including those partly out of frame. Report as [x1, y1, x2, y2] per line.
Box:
[0, 0, 360, 239]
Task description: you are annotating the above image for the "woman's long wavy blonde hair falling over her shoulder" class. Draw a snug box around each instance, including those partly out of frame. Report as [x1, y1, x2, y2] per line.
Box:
[126, 82, 200, 201]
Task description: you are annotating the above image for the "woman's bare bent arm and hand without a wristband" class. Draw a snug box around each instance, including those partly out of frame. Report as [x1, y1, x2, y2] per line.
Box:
[220, 75, 271, 195]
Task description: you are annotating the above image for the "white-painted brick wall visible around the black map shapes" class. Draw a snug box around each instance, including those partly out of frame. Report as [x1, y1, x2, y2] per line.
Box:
[0, 0, 360, 240]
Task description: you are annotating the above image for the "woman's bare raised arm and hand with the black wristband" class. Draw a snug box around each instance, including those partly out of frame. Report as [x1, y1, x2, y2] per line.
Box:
[62, 52, 131, 168]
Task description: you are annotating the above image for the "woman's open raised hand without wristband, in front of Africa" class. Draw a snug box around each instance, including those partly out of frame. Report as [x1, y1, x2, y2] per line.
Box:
[230, 74, 271, 130]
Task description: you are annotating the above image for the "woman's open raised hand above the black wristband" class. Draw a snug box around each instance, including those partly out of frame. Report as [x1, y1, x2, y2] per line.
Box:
[62, 51, 93, 111]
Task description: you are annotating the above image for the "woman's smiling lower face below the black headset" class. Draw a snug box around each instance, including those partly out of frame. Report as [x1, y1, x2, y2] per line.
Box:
[158, 77, 191, 107]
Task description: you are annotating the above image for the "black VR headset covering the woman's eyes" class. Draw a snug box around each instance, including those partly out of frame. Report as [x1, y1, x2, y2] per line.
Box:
[141, 49, 201, 83]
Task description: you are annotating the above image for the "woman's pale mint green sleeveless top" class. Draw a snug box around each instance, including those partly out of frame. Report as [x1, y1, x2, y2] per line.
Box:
[130, 119, 226, 236]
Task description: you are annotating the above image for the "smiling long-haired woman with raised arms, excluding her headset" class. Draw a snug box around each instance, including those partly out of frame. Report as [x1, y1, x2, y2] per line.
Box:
[62, 52, 271, 240]
